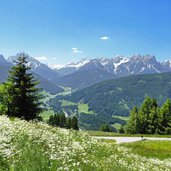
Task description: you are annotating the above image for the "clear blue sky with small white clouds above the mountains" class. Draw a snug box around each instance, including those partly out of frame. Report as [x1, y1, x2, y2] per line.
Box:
[0, 0, 171, 64]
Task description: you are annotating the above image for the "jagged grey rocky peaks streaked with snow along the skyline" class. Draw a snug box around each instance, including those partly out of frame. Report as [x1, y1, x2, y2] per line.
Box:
[53, 55, 171, 77]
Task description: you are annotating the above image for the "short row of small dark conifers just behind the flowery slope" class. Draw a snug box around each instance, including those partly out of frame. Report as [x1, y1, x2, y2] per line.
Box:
[48, 113, 79, 130]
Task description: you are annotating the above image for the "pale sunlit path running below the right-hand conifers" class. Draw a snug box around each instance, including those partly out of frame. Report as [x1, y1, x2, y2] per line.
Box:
[95, 136, 171, 144]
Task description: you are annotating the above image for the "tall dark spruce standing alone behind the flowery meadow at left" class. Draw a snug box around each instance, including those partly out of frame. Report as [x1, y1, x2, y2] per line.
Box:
[0, 53, 41, 120]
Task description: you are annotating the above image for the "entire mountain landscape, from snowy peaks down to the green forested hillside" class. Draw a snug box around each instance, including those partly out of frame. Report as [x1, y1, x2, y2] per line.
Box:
[0, 52, 171, 129]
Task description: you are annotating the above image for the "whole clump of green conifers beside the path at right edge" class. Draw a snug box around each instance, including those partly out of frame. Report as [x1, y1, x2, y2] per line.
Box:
[125, 97, 171, 134]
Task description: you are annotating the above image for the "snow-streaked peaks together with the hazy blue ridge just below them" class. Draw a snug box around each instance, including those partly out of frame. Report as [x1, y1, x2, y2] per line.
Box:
[53, 55, 171, 89]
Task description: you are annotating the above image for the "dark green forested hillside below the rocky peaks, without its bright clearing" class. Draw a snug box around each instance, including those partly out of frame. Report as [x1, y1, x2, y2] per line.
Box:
[51, 73, 171, 129]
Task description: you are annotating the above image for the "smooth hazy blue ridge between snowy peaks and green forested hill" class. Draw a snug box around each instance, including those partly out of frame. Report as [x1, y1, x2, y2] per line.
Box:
[53, 68, 113, 89]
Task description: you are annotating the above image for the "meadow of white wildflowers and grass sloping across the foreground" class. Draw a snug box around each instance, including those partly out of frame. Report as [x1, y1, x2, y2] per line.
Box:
[0, 116, 171, 171]
